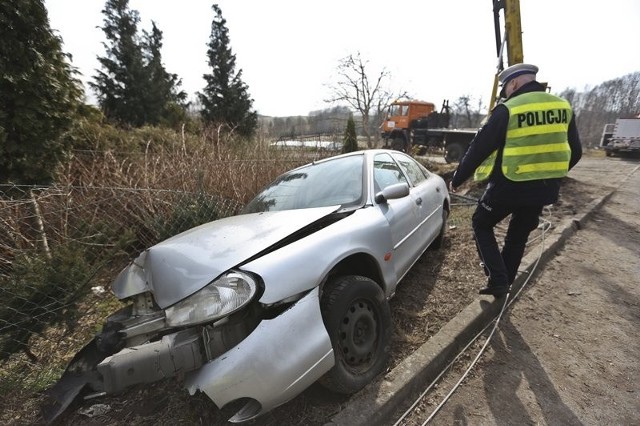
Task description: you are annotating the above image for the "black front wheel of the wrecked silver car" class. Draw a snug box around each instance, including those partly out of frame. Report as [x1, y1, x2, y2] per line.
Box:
[320, 275, 391, 394]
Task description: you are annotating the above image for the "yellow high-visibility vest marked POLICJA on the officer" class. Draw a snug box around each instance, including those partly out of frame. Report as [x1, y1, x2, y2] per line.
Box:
[473, 92, 573, 182]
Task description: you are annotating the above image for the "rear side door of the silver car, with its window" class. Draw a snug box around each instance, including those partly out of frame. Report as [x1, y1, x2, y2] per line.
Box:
[392, 152, 443, 249]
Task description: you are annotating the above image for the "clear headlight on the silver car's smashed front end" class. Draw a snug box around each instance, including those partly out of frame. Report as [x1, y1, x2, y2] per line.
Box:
[165, 271, 257, 327]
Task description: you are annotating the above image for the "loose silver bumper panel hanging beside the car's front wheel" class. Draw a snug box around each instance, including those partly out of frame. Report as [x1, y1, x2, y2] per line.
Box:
[186, 287, 335, 422]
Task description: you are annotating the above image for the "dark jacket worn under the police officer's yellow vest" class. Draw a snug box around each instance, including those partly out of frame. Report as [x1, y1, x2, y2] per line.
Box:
[451, 81, 582, 206]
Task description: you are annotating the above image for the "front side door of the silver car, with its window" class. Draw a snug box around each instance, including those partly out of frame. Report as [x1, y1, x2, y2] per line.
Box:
[373, 153, 424, 279]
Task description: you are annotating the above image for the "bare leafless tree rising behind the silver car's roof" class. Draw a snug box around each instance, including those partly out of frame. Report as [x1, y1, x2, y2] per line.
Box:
[325, 52, 402, 148]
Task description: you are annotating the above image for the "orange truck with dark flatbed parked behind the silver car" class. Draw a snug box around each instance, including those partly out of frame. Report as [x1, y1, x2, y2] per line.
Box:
[380, 100, 477, 163]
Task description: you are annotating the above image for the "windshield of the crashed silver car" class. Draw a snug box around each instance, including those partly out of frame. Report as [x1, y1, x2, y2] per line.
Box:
[242, 155, 364, 213]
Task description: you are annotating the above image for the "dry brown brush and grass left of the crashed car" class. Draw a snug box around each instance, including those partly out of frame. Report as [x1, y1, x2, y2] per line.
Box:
[0, 127, 338, 412]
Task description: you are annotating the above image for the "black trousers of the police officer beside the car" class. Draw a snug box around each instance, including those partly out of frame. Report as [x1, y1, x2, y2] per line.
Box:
[472, 200, 544, 286]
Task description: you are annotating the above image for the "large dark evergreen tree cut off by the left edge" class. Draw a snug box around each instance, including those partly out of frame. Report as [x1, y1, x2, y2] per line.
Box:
[0, 0, 84, 184]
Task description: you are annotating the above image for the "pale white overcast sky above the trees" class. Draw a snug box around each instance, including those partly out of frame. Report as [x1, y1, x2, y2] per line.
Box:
[45, 0, 640, 116]
